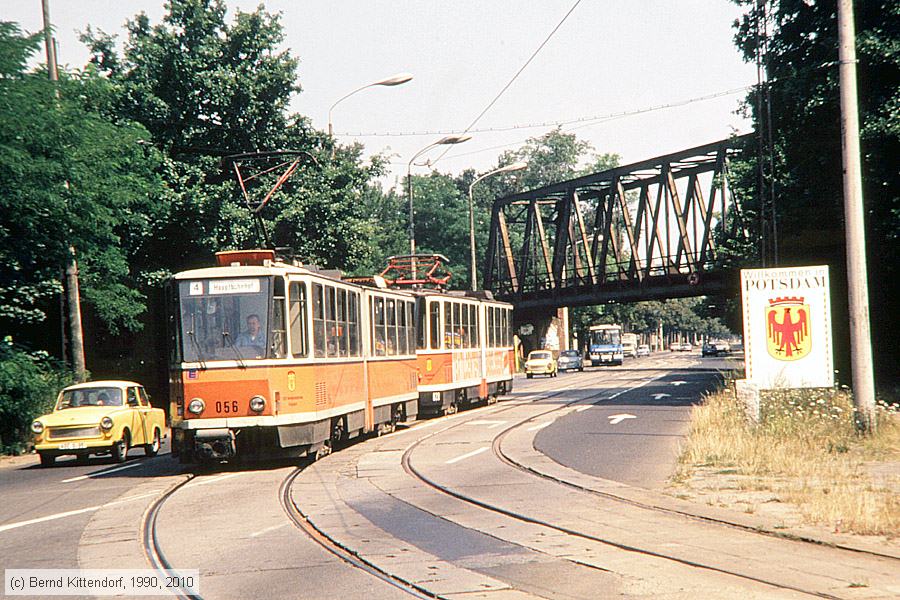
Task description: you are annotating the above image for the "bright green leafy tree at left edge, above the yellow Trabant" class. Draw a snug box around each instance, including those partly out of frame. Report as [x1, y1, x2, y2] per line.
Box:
[0, 23, 163, 330]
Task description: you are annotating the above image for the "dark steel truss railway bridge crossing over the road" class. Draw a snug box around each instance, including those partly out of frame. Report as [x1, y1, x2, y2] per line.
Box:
[483, 137, 748, 320]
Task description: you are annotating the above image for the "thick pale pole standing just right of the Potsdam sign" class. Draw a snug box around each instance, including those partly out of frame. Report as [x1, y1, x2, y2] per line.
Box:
[838, 0, 876, 431]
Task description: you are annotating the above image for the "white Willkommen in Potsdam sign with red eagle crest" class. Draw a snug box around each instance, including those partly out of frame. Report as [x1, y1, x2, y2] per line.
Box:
[741, 265, 834, 389]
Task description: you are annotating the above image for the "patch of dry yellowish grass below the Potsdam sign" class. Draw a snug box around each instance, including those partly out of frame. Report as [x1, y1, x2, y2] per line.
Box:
[676, 390, 900, 537]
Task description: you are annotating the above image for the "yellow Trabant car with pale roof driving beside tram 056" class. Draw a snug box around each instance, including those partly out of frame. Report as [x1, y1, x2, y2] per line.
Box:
[31, 381, 166, 467]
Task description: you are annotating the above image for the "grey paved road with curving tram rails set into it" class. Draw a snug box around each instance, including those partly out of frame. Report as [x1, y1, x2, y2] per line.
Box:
[0, 353, 900, 599]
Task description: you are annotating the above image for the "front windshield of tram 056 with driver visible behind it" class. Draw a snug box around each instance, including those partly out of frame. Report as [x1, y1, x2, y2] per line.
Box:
[178, 277, 270, 362]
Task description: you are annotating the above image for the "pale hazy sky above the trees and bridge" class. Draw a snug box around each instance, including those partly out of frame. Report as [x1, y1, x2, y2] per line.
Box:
[8, 0, 756, 185]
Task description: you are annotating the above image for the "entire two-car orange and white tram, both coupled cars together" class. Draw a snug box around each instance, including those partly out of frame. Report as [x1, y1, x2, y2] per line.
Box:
[167, 250, 514, 462]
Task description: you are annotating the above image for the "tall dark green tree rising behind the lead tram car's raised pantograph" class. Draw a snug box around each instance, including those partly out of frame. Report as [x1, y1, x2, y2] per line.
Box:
[83, 0, 384, 279]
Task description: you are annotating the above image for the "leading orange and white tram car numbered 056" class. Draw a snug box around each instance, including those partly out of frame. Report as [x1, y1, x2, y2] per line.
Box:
[168, 250, 419, 462]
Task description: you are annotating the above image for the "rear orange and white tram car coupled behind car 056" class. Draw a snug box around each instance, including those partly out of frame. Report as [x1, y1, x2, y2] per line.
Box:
[416, 291, 515, 415]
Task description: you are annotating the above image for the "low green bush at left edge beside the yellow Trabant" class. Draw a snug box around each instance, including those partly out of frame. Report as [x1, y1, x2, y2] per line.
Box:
[0, 338, 74, 454]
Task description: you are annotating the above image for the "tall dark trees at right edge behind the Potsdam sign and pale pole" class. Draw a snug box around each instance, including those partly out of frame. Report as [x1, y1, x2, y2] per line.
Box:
[735, 0, 900, 378]
